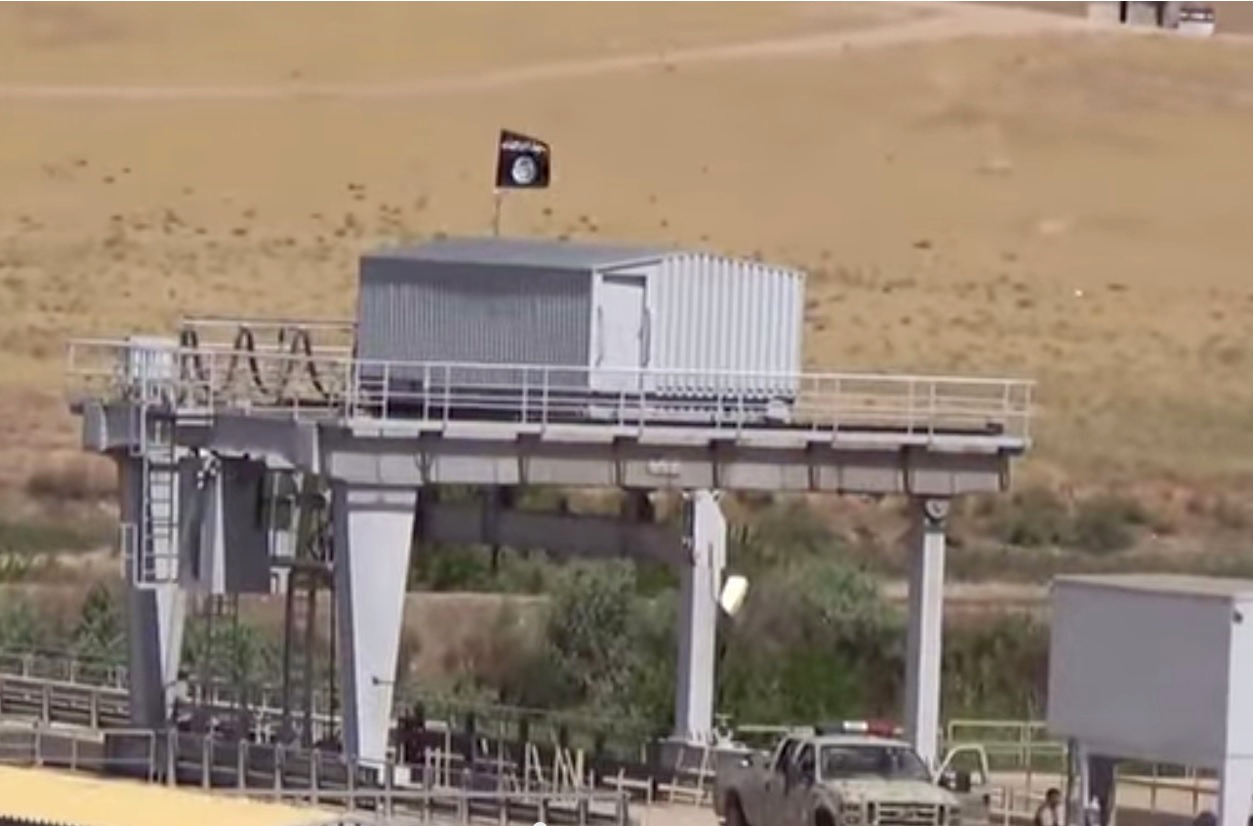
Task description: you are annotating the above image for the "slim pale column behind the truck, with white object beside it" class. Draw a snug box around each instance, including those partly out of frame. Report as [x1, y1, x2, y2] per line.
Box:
[675, 490, 727, 742]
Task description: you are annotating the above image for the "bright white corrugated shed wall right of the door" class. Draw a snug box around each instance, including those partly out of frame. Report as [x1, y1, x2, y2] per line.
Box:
[637, 253, 805, 395]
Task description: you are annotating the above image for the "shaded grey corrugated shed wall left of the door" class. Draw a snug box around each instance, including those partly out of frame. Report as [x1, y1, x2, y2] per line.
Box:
[357, 256, 592, 388]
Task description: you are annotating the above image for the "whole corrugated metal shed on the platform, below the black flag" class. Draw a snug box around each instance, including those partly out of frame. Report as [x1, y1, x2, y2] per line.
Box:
[357, 237, 805, 408]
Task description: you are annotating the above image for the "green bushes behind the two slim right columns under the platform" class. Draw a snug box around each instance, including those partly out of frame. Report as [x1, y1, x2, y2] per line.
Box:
[419, 504, 1048, 733]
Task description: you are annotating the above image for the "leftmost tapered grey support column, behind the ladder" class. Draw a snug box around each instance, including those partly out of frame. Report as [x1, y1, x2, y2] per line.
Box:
[118, 456, 188, 728]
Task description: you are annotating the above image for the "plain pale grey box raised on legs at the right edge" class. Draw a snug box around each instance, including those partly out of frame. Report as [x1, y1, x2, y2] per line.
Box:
[1048, 574, 1254, 767]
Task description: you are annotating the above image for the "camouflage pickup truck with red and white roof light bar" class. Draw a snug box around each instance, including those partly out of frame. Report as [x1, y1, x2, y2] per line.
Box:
[714, 723, 988, 826]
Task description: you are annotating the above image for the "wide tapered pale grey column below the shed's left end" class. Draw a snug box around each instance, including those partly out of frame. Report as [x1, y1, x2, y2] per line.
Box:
[331, 483, 418, 765]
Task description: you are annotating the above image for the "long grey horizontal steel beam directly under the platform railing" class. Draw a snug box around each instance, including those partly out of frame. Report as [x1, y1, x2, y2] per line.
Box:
[82, 401, 1022, 496]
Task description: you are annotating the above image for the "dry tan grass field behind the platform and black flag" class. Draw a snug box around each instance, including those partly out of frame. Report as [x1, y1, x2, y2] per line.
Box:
[0, 4, 1251, 503]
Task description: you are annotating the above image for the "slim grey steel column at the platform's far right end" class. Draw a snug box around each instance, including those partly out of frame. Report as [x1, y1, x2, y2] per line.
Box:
[904, 499, 949, 766]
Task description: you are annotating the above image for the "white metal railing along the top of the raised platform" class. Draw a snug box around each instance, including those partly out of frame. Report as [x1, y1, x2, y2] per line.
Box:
[66, 340, 1033, 445]
